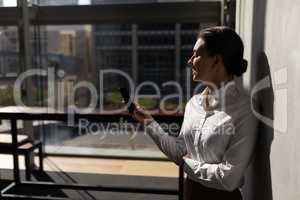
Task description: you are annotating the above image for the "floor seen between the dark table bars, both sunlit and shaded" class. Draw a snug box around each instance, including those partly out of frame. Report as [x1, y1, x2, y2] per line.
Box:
[0, 155, 178, 200]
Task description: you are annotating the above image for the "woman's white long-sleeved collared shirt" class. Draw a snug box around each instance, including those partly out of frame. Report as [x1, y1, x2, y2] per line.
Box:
[147, 80, 257, 191]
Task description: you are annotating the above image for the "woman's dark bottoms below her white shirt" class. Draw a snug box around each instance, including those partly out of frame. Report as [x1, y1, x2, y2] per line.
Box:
[184, 178, 243, 200]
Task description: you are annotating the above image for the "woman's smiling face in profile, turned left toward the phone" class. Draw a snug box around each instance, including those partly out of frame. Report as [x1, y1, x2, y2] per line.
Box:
[188, 38, 215, 81]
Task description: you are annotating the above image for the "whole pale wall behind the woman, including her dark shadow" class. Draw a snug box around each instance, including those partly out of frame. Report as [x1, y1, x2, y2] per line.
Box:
[237, 0, 300, 200]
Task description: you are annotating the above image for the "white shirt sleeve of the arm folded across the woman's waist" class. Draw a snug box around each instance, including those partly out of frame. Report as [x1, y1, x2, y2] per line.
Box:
[184, 112, 257, 191]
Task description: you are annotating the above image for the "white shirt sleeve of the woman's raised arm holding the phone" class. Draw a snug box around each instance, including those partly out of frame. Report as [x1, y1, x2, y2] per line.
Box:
[146, 104, 187, 165]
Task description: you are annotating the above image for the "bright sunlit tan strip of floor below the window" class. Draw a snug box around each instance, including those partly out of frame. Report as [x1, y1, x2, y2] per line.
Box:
[0, 155, 178, 177]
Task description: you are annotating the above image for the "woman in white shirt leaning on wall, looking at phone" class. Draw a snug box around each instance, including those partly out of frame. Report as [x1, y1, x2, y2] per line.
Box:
[133, 27, 256, 200]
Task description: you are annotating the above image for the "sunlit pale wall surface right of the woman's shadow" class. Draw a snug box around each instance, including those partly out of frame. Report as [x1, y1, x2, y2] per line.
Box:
[264, 0, 300, 200]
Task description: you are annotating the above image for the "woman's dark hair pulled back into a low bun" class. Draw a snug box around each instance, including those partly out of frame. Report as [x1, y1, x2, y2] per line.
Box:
[198, 26, 248, 76]
